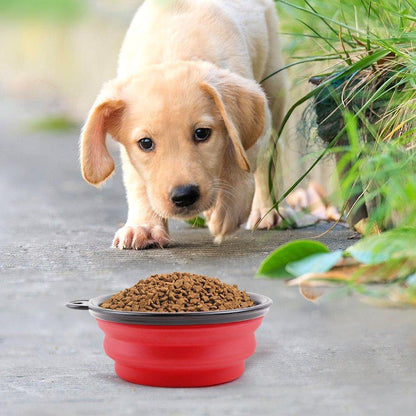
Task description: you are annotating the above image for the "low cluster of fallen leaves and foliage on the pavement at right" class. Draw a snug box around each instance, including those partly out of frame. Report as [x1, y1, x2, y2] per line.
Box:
[258, 228, 416, 306]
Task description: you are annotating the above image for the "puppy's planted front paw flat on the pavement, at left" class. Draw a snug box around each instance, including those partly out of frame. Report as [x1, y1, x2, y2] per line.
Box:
[113, 225, 169, 250]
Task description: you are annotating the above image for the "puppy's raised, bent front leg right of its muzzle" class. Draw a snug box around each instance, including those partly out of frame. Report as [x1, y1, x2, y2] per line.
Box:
[204, 163, 254, 243]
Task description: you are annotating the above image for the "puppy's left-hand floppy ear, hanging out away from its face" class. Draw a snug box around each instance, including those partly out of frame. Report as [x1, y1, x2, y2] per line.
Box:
[80, 81, 125, 185]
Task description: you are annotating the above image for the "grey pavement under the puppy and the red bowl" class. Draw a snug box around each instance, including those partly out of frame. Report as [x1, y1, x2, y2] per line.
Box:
[0, 104, 416, 416]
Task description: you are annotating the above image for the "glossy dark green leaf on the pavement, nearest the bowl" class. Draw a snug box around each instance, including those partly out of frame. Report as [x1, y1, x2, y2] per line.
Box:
[257, 240, 329, 279]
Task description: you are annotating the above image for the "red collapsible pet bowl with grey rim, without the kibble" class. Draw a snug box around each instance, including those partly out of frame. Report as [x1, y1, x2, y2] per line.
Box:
[67, 293, 272, 387]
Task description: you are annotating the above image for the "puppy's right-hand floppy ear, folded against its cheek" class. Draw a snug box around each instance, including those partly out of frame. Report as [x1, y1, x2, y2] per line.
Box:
[201, 70, 268, 172]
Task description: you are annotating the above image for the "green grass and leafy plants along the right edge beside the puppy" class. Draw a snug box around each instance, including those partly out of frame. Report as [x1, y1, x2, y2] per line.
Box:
[256, 0, 416, 306]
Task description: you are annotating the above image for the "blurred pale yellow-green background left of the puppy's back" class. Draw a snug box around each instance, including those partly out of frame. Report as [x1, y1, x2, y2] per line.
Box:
[0, 0, 142, 122]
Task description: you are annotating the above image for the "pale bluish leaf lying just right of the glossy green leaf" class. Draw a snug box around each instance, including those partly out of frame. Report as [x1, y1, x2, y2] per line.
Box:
[286, 250, 343, 277]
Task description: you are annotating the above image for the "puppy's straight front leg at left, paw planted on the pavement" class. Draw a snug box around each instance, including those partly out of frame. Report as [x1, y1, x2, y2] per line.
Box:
[113, 149, 169, 250]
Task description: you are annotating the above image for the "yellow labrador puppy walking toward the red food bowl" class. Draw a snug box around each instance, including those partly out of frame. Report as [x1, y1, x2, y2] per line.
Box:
[81, 0, 285, 249]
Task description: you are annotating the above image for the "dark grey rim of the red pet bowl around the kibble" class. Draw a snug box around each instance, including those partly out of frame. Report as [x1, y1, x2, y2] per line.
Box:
[88, 292, 273, 326]
